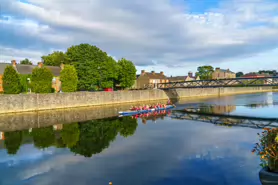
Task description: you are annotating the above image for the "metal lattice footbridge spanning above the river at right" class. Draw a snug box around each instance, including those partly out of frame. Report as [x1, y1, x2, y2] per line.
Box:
[145, 76, 278, 89]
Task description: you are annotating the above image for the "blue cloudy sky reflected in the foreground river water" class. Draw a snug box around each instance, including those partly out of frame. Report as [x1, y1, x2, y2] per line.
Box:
[0, 119, 259, 185]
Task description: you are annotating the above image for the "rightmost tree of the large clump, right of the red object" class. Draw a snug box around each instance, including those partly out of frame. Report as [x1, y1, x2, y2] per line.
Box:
[118, 58, 136, 88]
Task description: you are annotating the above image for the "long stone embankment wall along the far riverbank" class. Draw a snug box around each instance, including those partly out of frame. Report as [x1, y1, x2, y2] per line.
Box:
[0, 87, 271, 113]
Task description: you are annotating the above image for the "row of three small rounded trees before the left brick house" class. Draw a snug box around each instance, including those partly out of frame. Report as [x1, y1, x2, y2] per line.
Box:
[2, 65, 78, 94]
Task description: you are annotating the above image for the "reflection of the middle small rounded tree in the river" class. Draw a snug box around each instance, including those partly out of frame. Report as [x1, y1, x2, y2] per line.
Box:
[32, 126, 55, 148]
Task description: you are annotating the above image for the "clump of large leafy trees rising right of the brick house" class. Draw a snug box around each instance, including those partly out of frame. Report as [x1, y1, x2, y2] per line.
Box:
[42, 44, 136, 91]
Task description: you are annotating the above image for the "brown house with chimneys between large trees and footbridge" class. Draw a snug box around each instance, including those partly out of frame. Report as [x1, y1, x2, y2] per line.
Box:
[136, 70, 169, 89]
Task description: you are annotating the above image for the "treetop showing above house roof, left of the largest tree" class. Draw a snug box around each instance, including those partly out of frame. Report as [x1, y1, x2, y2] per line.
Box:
[42, 51, 67, 66]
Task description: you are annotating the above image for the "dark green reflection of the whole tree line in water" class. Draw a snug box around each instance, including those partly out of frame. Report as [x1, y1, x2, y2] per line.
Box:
[5, 117, 138, 157]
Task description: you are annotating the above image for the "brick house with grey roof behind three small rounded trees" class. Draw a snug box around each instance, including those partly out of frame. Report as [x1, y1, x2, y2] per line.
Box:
[0, 60, 64, 92]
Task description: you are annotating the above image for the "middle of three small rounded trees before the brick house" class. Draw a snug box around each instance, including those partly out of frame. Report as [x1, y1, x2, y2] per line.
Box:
[31, 67, 53, 93]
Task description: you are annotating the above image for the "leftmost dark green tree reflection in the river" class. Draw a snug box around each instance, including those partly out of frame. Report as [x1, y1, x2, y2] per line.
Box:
[5, 131, 22, 155]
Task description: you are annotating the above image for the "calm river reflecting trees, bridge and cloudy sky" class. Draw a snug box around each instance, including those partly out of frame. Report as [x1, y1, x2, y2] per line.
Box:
[0, 92, 278, 185]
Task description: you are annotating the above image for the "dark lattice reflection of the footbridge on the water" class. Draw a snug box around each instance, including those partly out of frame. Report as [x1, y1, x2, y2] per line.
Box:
[171, 110, 278, 129]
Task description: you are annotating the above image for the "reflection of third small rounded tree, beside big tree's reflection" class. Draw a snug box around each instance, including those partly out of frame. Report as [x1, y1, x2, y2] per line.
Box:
[61, 123, 80, 148]
